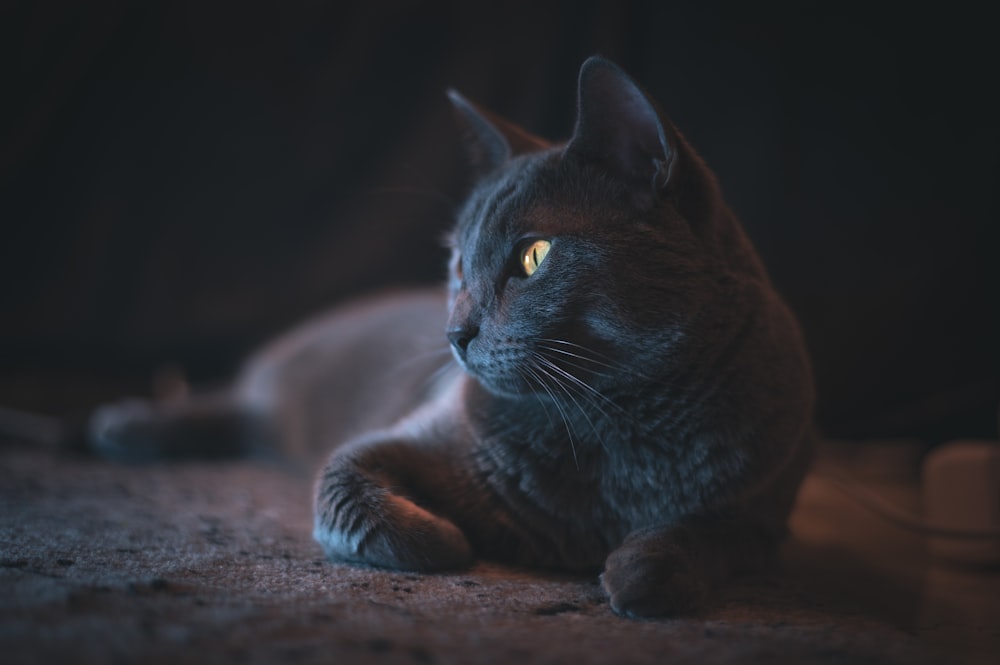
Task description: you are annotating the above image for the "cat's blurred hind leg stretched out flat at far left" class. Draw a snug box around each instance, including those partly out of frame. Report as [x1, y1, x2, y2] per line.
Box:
[87, 392, 273, 462]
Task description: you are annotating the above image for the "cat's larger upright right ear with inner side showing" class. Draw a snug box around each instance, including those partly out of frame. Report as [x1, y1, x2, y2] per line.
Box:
[564, 56, 676, 206]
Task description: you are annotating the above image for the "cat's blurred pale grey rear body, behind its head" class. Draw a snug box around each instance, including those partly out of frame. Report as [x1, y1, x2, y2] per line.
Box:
[236, 289, 454, 455]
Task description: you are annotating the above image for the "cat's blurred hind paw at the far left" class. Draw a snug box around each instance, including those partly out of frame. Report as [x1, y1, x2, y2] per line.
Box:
[87, 399, 155, 460]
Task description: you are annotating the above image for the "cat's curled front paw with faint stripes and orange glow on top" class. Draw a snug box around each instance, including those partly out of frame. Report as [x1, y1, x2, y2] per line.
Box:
[313, 494, 472, 572]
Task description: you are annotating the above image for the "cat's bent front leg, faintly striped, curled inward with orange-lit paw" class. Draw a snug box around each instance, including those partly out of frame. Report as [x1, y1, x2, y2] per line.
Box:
[313, 442, 472, 571]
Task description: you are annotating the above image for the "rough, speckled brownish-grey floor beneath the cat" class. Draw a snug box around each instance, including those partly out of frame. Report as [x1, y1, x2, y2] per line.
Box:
[0, 438, 1000, 665]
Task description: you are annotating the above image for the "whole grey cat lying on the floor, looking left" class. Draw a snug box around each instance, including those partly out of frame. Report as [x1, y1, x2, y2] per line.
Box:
[92, 58, 813, 616]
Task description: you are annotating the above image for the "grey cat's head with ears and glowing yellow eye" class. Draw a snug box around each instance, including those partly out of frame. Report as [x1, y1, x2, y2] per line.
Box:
[447, 57, 752, 402]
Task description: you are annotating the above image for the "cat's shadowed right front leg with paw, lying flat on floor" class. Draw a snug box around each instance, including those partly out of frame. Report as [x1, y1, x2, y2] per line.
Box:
[601, 518, 775, 618]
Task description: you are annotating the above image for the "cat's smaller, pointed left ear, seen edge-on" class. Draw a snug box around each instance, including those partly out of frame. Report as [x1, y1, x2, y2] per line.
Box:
[448, 90, 551, 175]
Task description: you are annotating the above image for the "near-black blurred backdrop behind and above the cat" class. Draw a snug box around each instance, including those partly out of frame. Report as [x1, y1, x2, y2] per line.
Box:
[0, 0, 1000, 442]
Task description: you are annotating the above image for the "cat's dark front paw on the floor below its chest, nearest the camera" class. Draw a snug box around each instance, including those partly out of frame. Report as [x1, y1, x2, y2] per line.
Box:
[601, 533, 707, 618]
